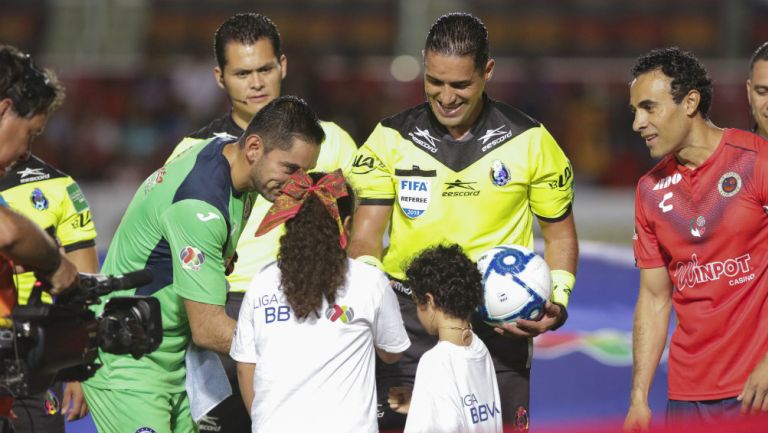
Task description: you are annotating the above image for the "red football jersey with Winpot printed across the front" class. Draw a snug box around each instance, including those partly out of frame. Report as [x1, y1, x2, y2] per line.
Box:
[634, 129, 768, 401]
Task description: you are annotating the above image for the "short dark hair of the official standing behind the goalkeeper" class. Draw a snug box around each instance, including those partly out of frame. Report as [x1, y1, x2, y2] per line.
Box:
[213, 12, 281, 70]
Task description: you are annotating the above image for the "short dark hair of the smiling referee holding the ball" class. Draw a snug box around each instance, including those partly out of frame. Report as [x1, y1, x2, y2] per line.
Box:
[424, 12, 490, 71]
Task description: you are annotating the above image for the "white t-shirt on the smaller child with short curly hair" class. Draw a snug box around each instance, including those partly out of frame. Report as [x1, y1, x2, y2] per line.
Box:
[405, 333, 502, 433]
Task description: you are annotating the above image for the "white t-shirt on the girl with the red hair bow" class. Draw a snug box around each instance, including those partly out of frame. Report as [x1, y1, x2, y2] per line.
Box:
[230, 259, 411, 433]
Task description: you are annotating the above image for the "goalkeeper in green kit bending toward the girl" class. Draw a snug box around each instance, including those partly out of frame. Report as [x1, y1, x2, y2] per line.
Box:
[83, 96, 324, 433]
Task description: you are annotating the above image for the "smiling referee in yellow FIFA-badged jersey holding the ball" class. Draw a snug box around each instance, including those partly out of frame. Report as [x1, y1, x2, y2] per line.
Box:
[349, 13, 578, 431]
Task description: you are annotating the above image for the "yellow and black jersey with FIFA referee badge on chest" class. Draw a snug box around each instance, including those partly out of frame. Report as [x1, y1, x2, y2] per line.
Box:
[350, 96, 573, 279]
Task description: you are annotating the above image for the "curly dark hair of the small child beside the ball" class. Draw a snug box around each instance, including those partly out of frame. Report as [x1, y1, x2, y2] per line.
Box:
[405, 244, 483, 319]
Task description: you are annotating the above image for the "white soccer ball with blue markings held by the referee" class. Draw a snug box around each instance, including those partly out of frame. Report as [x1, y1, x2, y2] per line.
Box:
[477, 245, 552, 326]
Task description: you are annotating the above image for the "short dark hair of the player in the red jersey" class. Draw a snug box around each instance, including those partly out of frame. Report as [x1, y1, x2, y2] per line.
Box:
[632, 47, 714, 119]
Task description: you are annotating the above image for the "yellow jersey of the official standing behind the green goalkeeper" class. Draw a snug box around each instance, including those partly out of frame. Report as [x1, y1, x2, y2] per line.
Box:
[168, 115, 357, 292]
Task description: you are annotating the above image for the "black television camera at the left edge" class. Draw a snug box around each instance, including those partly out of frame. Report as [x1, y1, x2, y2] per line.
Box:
[0, 269, 163, 402]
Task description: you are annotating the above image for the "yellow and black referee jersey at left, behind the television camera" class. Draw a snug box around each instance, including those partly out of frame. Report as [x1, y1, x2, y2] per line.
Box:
[0, 156, 96, 304]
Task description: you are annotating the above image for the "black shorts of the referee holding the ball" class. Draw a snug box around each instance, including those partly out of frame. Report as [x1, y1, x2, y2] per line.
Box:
[376, 281, 531, 431]
